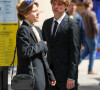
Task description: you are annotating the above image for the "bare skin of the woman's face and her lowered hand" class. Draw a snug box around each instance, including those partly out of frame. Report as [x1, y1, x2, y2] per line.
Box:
[24, 4, 56, 86]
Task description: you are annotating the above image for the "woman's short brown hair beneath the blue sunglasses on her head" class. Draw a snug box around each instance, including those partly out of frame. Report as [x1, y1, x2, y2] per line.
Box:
[16, 1, 39, 20]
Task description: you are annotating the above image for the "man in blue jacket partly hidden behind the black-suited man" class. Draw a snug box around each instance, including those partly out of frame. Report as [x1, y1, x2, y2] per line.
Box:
[66, 0, 85, 49]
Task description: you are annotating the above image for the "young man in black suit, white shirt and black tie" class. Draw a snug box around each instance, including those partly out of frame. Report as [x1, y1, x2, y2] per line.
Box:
[42, 0, 81, 90]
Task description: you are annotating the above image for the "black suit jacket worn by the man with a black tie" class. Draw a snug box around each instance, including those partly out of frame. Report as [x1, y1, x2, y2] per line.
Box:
[42, 15, 81, 81]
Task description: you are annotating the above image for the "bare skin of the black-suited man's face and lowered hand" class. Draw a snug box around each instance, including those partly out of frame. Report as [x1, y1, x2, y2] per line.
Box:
[52, 1, 75, 90]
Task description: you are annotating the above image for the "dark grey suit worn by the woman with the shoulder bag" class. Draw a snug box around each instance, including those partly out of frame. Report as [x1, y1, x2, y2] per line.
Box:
[16, 22, 55, 90]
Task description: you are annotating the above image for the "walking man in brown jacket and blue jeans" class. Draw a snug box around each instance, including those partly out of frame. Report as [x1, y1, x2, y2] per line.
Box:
[79, 0, 98, 74]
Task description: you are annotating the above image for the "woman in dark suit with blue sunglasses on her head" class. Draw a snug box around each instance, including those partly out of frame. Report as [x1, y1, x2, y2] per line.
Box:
[16, 0, 56, 90]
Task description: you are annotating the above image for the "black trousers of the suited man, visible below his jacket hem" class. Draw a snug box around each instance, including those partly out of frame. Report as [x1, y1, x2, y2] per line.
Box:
[50, 80, 78, 90]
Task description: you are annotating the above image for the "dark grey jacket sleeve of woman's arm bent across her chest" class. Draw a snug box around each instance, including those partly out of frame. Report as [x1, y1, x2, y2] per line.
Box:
[17, 27, 47, 58]
